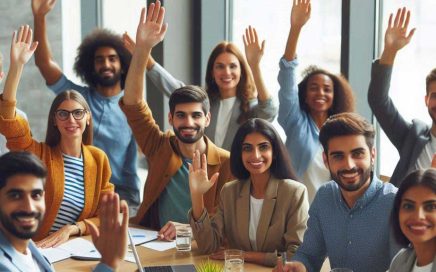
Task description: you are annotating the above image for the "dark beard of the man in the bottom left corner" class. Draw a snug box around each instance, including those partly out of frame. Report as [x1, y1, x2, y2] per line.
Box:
[0, 211, 43, 240]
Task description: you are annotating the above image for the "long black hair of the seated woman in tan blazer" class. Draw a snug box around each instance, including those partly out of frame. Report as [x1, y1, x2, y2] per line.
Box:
[230, 118, 298, 180]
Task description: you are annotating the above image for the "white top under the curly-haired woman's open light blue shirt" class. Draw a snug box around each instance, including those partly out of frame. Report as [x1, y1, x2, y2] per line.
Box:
[303, 143, 332, 203]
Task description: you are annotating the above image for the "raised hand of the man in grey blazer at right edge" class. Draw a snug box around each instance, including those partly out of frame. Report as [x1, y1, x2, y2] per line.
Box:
[385, 8, 415, 51]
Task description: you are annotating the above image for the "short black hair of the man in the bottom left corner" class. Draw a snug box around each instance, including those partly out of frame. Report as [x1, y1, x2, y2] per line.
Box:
[0, 151, 47, 189]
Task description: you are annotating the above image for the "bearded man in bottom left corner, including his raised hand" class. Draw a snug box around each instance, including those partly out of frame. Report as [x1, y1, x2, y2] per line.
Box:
[0, 152, 129, 272]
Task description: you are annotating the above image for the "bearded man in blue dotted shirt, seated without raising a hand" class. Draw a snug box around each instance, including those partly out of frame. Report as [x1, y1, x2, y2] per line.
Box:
[284, 113, 400, 272]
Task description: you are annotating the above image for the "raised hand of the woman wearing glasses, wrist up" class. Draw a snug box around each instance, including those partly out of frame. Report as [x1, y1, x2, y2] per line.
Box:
[11, 25, 38, 65]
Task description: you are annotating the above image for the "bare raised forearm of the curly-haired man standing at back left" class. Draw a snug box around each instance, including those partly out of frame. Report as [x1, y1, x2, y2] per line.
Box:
[32, 0, 62, 85]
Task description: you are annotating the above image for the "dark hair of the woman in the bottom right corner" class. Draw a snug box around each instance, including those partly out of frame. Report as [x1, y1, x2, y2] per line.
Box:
[391, 168, 436, 247]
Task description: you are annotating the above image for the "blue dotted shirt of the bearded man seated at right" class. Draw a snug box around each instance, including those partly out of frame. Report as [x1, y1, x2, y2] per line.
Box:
[292, 178, 401, 272]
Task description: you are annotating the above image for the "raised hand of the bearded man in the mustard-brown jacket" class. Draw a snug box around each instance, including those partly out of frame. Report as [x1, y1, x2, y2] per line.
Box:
[136, 0, 167, 48]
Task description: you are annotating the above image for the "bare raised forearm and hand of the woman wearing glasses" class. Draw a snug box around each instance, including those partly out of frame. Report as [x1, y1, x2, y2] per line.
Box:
[1, 25, 38, 119]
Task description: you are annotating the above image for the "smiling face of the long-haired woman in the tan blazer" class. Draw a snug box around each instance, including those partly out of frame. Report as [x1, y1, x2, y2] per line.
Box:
[242, 132, 273, 176]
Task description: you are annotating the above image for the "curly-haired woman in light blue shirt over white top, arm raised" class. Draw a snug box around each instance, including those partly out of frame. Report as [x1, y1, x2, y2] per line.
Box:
[277, 0, 354, 202]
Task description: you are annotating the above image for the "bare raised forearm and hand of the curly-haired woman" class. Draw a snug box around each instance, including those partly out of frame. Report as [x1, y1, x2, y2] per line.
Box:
[284, 0, 311, 61]
